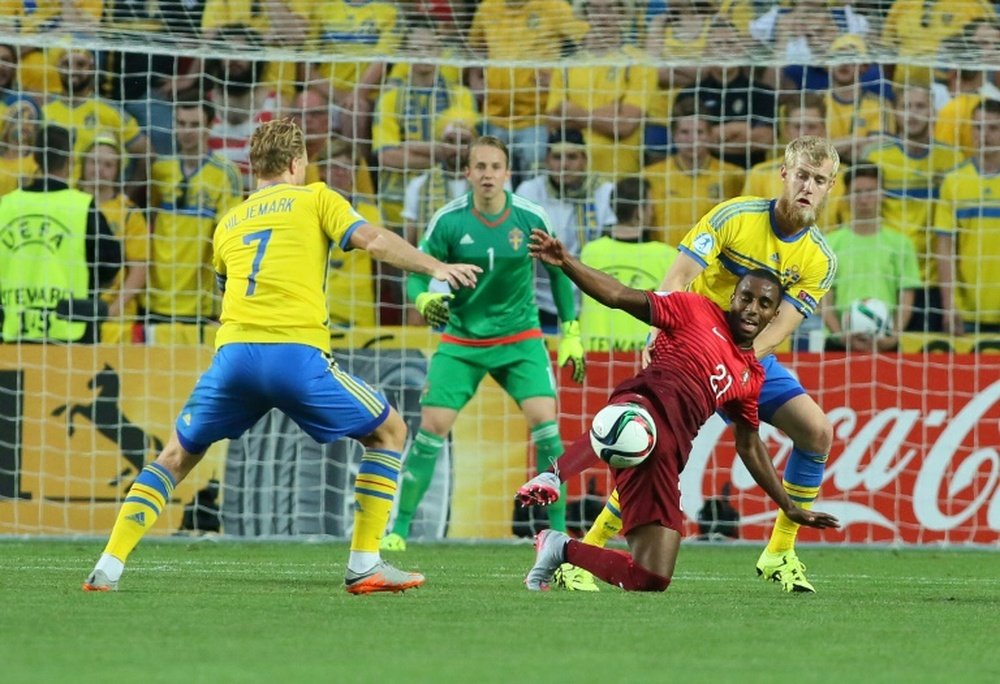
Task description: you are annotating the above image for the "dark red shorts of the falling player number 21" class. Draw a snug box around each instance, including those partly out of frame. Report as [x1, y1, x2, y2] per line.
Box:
[611, 391, 690, 535]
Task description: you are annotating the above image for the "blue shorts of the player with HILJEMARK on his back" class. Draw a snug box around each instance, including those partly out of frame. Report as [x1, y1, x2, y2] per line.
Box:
[176, 343, 389, 454]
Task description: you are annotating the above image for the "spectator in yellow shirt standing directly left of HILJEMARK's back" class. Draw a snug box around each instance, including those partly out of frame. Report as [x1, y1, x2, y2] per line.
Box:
[146, 93, 243, 345]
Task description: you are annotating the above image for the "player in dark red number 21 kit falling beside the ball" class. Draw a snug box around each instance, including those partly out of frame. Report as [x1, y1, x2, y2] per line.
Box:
[518, 230, 838, 591]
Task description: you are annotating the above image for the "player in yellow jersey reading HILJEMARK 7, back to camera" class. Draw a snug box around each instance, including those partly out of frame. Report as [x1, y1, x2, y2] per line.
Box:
[83, 119, 479, 594]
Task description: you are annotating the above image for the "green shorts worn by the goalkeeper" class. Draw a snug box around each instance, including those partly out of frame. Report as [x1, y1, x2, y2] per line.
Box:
[420, 338, 556, 411]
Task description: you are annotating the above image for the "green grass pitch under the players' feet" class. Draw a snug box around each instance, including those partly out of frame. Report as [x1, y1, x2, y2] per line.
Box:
[0, 540, 1000, 684]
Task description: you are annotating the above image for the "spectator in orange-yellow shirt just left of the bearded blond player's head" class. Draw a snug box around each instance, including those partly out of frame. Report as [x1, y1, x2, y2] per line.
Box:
[642, 96, 743, 247]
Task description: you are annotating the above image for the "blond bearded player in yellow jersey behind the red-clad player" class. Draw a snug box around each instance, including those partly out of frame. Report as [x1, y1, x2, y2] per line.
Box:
[552, 136, 840, 592]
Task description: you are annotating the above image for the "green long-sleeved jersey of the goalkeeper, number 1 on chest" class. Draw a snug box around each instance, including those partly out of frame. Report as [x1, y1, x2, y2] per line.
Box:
[407, 192, 576, 340]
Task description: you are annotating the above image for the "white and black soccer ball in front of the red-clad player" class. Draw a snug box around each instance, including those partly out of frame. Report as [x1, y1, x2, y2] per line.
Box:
[590, 404, 656, 468]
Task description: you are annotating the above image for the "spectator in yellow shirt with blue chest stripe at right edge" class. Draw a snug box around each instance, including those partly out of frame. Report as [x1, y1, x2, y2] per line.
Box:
[934, 100, 1000, 335]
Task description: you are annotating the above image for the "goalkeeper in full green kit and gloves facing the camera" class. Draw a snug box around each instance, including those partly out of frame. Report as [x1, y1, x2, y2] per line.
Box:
[381, 136, 584, 551]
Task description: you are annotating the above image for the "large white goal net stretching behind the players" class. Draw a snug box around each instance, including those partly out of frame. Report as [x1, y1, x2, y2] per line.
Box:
[0, 0, 1000, 546]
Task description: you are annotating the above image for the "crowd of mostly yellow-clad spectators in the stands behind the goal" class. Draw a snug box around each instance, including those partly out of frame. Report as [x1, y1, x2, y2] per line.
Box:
[0, 0, 1000, 343]
